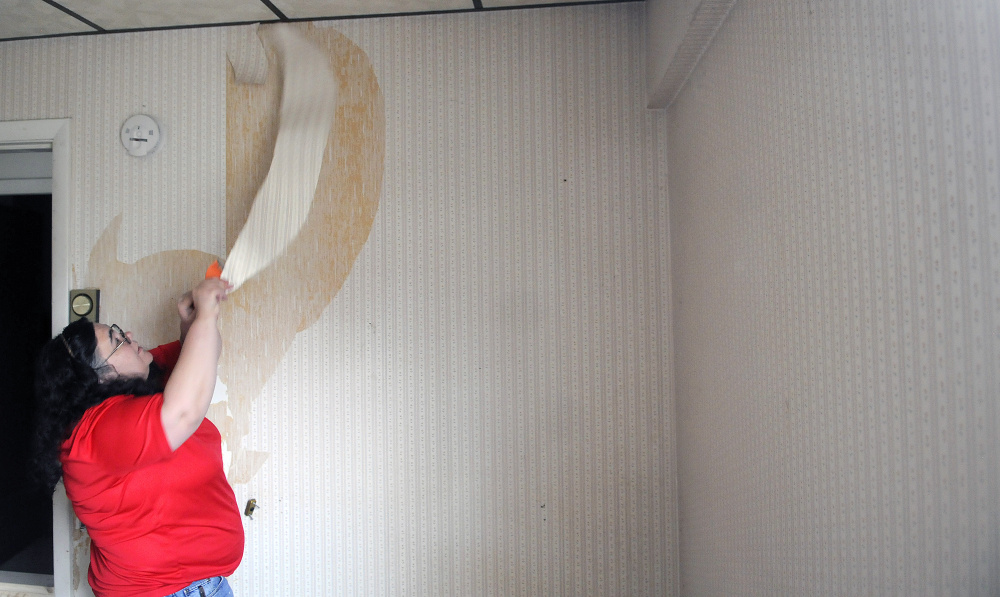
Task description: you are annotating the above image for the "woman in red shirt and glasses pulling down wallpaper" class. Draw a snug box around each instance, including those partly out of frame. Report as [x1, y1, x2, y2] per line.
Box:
[35, 278, 244, 597]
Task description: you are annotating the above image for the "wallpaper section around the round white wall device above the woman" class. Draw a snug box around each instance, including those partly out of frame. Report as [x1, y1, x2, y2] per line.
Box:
[0, 29, 226, 270]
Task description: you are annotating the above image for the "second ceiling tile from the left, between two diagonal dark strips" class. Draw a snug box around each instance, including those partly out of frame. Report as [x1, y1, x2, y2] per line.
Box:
[59, 0, 277, 30]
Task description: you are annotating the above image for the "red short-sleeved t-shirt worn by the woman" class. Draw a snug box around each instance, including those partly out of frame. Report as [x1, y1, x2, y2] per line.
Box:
[60, 342, 244, 597]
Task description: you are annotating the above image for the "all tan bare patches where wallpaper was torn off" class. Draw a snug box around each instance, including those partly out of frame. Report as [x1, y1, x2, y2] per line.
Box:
[88, 24, 385, 484]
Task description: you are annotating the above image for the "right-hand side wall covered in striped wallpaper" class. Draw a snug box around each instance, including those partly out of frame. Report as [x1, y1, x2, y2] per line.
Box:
[668, 0, 1000, 595]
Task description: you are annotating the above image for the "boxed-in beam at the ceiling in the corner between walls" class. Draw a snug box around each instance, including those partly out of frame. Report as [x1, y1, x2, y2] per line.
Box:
[646, 0, 736, 108]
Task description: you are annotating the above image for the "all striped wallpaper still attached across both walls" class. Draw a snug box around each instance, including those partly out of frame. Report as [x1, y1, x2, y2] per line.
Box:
[0, 0, 1000, 595]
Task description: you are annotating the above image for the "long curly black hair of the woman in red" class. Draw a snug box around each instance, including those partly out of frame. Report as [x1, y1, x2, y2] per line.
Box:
[32, 319, 163, 491]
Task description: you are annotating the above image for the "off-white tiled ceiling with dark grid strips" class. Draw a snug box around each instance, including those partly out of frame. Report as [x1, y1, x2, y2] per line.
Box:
[0, 0, 629, 41]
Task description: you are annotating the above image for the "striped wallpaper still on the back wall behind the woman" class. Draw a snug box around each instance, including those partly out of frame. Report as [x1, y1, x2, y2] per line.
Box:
[0, 3, 678, 595]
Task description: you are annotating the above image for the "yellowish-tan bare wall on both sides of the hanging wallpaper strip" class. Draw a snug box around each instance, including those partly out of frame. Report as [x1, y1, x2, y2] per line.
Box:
[219, 26, 385, 483]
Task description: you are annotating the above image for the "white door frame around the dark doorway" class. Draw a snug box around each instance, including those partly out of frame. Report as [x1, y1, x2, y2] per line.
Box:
[0, 118, 74, 597]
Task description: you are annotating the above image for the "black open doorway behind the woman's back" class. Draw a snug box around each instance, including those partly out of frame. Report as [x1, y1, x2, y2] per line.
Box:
[0, 195, 53, 577]
